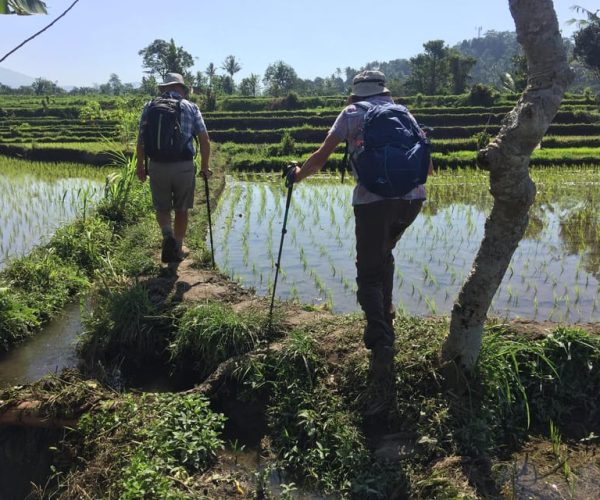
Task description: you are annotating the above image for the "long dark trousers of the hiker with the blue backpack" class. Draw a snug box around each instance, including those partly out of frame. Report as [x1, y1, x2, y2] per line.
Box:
[354, 200, 423, 349]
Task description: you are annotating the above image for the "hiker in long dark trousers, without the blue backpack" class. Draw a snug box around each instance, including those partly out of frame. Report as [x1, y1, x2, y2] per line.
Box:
[287, 71, 432, 415]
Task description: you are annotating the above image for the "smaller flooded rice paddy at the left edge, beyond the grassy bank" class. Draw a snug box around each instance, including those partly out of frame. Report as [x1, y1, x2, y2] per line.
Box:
[0, 156, 106, 269]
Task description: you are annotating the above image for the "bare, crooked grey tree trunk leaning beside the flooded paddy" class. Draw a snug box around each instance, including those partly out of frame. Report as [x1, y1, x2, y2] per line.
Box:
[442, 0, 573, 371]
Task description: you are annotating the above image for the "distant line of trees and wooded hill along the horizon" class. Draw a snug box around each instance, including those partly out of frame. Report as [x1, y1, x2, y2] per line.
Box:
[0, 17, 600, 98]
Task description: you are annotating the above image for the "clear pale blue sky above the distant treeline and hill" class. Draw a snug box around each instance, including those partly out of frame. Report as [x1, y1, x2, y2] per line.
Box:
[0, 0, 580, 86]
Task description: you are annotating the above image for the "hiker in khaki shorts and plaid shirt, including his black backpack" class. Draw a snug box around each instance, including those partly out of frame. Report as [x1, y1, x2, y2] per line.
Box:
[137, 73, 211, 263]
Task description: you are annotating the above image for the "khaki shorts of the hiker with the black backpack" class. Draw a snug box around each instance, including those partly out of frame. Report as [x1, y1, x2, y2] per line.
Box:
[148, 160, 196, 212]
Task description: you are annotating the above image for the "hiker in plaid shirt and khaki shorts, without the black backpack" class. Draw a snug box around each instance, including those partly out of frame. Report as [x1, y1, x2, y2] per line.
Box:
[137, 73, 211, 263]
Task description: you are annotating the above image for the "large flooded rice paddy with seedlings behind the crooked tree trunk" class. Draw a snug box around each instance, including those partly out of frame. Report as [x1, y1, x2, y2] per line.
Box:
[215, 166, 600, 322]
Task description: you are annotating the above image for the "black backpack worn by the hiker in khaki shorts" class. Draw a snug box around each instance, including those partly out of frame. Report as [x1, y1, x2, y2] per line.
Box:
[143, 95, 192, 162]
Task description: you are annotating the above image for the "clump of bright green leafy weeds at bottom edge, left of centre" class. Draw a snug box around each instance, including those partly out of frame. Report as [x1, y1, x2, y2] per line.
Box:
[69, 394, 225, 499]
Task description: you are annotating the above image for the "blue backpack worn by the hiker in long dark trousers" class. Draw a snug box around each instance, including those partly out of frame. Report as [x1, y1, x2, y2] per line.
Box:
[351, 101, 431, 198]
